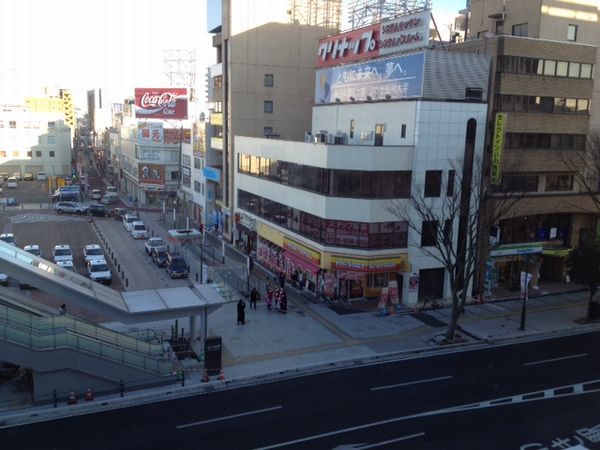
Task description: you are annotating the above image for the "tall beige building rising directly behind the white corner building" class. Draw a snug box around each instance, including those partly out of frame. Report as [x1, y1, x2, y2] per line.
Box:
[203, 0, 342, 238]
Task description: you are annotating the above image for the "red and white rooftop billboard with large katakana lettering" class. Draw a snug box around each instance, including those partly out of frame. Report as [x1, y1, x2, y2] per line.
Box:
[317, 10, 430, 68]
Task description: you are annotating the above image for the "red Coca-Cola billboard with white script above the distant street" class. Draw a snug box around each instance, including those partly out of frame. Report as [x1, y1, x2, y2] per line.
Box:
[135, 88, 187, 120]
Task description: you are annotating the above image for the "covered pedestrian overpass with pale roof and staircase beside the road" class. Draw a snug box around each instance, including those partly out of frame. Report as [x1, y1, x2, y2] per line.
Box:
[0, 241, 237, 401]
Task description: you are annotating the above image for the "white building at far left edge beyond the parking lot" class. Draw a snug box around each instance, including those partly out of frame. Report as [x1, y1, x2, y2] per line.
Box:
[0, 105, 72, 177]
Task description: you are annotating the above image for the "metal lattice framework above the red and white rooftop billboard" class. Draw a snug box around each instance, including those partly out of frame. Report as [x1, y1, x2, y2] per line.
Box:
[348, 0, 431, 29]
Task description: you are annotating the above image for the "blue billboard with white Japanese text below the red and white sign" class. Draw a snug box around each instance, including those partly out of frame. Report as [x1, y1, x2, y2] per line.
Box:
[315, 53, 425, 105]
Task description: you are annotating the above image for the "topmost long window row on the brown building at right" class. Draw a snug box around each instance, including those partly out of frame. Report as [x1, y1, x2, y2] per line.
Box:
[498, 55, 594, 80]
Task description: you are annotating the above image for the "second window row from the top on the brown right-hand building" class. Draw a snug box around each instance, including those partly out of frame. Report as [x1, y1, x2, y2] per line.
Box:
[496, 95, 590, 114]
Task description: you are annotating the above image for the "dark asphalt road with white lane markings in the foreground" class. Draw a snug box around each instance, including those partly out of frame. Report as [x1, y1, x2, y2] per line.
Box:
[0, 333, 600, 450]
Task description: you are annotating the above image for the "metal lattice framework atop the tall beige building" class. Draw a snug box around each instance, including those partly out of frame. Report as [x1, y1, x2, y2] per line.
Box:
[288, 0, 342, 30]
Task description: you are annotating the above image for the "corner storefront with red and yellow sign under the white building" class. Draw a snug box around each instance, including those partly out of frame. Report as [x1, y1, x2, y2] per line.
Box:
[330, 255, 408, 299]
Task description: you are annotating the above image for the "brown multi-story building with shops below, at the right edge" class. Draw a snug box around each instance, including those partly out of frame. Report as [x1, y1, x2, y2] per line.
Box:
[452, 0, 600, 293]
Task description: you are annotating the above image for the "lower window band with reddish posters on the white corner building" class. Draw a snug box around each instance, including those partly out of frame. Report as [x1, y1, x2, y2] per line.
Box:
[238, 189, 408, 248]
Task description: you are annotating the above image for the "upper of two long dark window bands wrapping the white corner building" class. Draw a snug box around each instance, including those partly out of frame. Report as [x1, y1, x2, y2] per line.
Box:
[238, 154, 411, 198]
